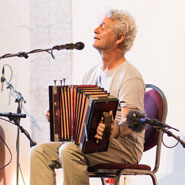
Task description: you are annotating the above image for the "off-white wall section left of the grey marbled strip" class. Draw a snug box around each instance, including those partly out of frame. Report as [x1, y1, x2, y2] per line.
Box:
[0, 0, 30, 185]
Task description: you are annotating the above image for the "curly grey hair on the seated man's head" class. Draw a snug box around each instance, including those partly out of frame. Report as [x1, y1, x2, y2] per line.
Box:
[106, 10, 137, 53]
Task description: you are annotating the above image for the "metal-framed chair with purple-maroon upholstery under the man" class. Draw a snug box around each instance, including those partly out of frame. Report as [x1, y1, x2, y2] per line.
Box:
[88, 84, 167, 185]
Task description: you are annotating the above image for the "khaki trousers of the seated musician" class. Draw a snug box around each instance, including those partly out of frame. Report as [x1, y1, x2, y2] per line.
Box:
[30, 139, 137, 185]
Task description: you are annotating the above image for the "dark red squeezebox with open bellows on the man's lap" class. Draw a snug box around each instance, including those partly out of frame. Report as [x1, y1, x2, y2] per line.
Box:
[49, 85, 118, 153]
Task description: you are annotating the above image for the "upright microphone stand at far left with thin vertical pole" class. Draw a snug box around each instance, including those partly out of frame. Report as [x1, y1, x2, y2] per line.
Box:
[1, 77, 36, 185]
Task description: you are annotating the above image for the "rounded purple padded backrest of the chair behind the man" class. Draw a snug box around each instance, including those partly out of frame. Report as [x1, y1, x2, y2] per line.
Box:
[144, 84, 167, 151]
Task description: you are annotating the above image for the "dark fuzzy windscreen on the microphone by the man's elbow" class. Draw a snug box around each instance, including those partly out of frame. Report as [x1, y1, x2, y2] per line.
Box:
[127, 110, 145, 133]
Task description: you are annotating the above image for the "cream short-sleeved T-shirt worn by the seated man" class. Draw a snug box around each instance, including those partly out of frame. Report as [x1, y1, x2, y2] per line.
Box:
[83, 61, 145, 158]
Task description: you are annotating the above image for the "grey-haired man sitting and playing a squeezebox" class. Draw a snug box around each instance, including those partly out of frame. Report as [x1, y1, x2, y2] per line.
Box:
[30, 10, 145, 185]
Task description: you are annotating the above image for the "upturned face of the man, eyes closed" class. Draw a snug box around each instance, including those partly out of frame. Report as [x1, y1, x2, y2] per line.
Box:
[93, 17, 116, 52]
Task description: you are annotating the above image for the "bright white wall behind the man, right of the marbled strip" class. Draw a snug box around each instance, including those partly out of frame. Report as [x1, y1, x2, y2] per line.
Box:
[73, 0, 185, 185]
